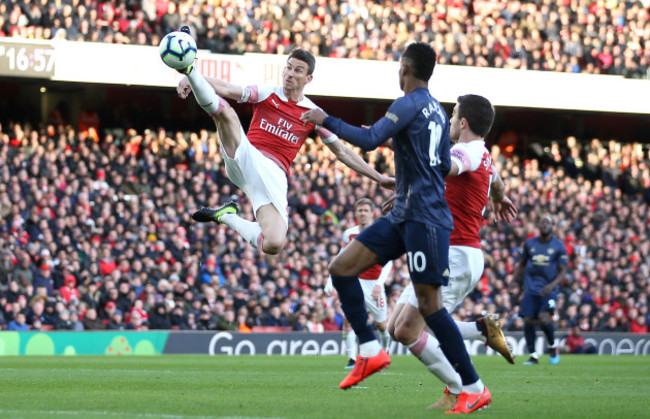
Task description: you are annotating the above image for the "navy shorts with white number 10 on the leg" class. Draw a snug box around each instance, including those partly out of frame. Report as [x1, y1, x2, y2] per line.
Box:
[355, 218, 450, 285]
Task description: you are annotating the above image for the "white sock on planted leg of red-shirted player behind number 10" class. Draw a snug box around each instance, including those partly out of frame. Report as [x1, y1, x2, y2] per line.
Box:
[406, 332, 462, 394]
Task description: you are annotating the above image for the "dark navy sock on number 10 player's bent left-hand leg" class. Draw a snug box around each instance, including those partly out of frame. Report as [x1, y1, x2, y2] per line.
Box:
[332, 276, 377, 344]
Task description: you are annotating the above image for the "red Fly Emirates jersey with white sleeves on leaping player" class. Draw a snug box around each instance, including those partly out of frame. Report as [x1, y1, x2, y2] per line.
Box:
[247, 86, 338, 175]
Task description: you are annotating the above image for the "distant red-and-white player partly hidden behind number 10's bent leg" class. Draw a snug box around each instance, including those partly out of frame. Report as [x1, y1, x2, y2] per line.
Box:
[325, 198, 393, 368]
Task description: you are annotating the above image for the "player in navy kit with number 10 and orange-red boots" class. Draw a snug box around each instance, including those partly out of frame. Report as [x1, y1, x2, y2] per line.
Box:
[302, 42, 492, 413]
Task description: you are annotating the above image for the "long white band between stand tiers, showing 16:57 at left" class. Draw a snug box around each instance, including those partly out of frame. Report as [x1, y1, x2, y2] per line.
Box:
[0, 38, 650, 114]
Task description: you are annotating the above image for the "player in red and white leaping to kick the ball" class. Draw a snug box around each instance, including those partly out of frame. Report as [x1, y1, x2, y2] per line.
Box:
[177, 26, 394, 254]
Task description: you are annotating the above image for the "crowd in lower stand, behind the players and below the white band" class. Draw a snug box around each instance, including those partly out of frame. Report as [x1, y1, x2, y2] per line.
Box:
[0, 119, 650, 333]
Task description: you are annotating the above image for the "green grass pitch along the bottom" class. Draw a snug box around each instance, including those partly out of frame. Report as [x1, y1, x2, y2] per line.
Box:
[0, 355, 650, 418]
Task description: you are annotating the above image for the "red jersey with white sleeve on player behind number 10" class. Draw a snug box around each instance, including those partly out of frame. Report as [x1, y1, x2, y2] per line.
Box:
[445, 140, 496, 249]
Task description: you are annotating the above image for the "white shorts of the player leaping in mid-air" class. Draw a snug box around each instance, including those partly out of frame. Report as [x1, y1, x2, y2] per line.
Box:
[221, 129, 289, 226]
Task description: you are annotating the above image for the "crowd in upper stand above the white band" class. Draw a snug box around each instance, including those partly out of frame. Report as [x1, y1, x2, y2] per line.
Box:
[0, 0, 650, 78]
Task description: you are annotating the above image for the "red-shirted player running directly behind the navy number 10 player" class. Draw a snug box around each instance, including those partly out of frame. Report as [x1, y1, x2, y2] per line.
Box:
[389, 95, 517, 409]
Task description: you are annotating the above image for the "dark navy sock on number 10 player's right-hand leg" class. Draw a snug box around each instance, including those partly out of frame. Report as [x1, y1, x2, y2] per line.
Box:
[424, 308, 478, 385]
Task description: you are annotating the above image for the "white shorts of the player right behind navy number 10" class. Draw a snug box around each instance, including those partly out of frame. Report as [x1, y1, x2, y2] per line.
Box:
[397, 246, 485, 313]
